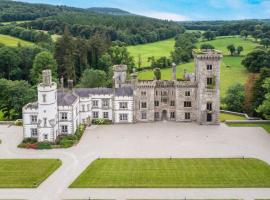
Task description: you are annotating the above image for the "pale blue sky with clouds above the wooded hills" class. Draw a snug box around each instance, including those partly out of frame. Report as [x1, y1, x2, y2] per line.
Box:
[16, 0, 270, 21]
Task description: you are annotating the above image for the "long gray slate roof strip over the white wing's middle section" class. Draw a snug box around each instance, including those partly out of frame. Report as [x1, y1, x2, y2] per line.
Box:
[74, 87, 133, 97]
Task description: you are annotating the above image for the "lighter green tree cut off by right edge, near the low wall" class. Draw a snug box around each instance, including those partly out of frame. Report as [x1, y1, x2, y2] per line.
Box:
[256, 78, 270, 119]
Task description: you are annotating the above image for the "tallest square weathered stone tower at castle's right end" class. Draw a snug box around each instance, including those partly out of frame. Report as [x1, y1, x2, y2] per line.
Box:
[193, 50, 222, 124]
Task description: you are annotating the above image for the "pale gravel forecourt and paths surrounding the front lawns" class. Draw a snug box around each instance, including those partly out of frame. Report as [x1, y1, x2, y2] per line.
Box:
[0, 122, 270, 200]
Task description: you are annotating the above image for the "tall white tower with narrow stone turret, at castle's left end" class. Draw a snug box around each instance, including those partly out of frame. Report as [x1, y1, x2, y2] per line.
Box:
[37, 70, 58, 142]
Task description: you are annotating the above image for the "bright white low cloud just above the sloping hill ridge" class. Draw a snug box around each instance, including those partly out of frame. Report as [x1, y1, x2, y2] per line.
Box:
[140, 11, 190, 21]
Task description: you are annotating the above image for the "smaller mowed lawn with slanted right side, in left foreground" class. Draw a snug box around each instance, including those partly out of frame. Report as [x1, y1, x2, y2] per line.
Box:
[0, 159, 62, 188]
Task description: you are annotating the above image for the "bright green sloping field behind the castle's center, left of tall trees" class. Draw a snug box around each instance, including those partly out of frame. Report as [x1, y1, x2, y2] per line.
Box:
[127, 38, 175, 67]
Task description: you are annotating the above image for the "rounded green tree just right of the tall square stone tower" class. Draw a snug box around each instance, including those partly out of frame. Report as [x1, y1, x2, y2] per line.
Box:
[224, 83, 245, 112]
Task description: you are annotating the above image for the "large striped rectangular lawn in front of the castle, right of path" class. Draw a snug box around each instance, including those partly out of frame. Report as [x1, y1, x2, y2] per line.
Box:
[70, 158, 270, 188]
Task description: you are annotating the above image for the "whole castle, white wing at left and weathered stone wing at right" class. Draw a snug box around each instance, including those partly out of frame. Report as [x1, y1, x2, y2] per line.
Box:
[23, 50, 222, 142]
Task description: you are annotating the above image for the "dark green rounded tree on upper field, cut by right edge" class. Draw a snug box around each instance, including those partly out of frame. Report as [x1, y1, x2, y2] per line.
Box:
[242, 49, 270, 73]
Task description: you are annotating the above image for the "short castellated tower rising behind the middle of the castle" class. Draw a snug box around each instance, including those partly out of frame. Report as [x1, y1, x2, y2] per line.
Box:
[113, 65, 127, 88]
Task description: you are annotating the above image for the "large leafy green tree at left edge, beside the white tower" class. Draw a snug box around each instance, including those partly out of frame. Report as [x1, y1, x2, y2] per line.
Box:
[0, 79, 36, 120]
